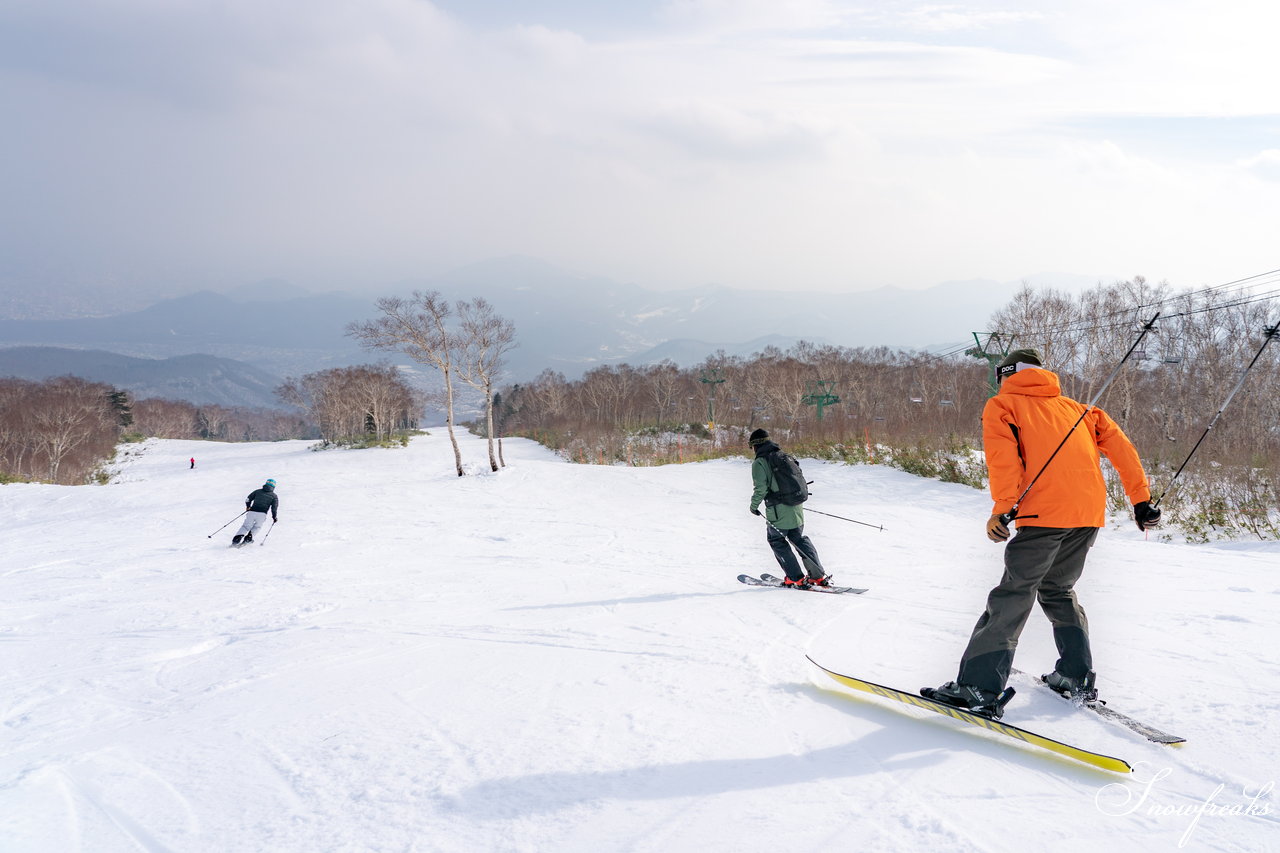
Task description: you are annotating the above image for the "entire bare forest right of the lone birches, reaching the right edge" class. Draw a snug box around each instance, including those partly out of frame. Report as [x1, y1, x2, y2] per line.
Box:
[499, 278, 1280, 538]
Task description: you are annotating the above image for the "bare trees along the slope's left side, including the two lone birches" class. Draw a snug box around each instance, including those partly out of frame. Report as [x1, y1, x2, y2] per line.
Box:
[0, 291, 516, 484]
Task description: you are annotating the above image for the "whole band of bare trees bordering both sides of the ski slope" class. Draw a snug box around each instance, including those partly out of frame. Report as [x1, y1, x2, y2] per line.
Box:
[0, 278, 1280, 538]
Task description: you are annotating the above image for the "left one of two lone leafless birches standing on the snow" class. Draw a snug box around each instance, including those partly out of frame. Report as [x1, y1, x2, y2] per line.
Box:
[347, 291, 462, 476]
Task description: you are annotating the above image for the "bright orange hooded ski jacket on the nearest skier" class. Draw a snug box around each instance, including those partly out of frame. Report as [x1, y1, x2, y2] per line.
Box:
[982, 368, 1151, 528]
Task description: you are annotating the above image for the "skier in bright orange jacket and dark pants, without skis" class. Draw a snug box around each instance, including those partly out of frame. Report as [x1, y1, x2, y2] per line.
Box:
[920, 350, 1160, 719]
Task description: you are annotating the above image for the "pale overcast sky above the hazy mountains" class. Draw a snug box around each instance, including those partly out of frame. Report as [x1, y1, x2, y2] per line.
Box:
[0, 0, 1280, 298]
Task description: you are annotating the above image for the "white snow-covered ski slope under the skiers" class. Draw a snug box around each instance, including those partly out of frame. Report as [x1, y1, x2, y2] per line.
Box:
[0, 433, 1280, 853]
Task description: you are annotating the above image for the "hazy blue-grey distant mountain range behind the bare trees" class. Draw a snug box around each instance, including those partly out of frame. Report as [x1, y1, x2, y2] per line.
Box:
[0, 257, 1049, 405]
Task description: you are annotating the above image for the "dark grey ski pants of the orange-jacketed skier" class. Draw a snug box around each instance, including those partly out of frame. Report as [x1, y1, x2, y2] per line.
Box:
[956, 528, 1098, 693]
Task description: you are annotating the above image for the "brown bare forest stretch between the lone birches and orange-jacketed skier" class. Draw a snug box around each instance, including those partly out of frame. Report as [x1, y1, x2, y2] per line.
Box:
[499, 343, 988, 465]
